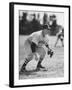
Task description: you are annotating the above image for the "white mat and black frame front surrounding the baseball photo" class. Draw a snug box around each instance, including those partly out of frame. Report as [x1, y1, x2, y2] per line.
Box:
[10, 3, 70, 87]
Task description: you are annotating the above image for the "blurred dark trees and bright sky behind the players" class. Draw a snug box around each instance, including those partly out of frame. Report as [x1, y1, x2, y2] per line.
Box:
[19, 10, 64, 36]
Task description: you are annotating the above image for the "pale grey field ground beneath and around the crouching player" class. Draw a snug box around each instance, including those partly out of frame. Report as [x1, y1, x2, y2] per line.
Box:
[19, 36, 64, 79]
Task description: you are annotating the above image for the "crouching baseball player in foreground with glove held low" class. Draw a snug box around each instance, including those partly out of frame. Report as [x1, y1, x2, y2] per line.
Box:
[20, 25, 53, 72]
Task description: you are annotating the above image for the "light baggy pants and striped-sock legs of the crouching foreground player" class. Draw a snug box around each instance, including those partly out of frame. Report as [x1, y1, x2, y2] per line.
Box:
[21, 40, 46, 72]
